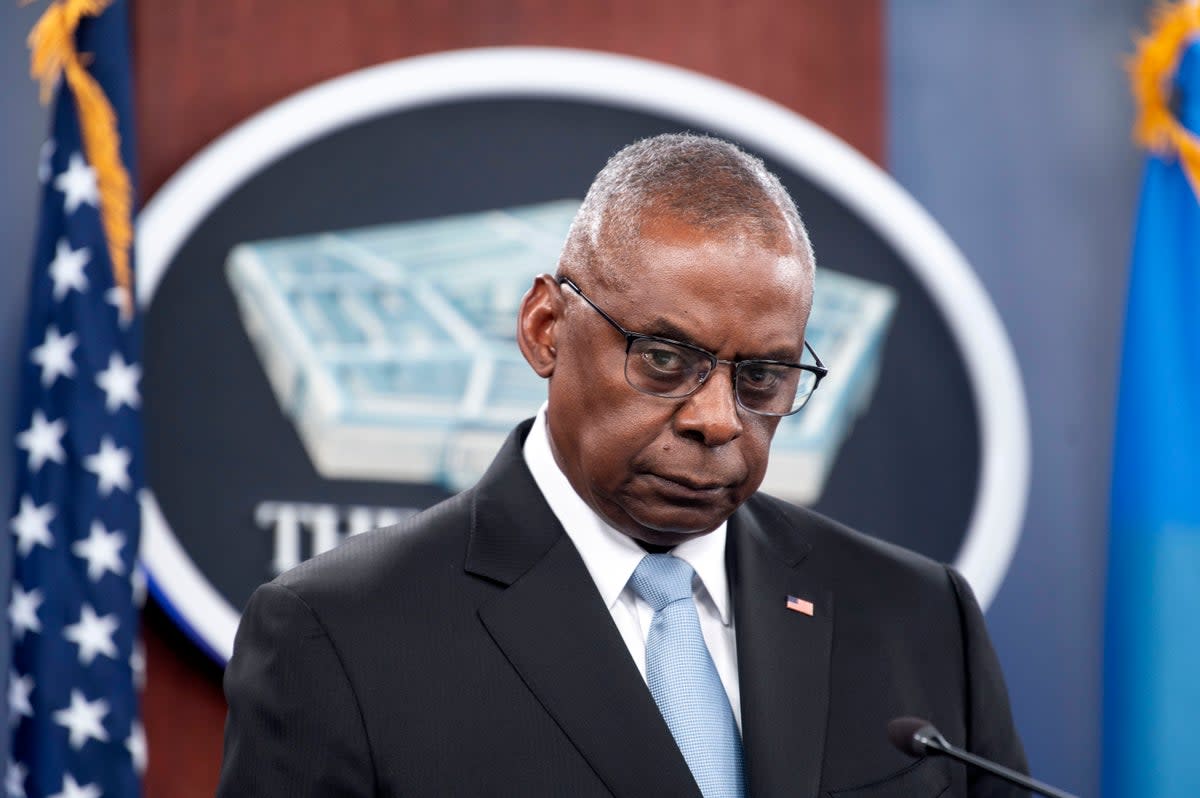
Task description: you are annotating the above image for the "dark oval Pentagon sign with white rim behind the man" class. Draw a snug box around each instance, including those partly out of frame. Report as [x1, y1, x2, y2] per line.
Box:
[137, 48, 1030, 662]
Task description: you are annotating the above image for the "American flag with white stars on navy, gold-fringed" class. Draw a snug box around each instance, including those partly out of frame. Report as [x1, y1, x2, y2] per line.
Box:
[5, 0, 146, 798]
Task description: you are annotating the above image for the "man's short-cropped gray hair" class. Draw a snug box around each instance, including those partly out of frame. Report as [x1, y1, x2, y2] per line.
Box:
[559, 133, 815, 282]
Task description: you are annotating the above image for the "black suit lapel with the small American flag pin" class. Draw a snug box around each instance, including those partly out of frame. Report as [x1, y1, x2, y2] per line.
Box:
[727, 499, 833, 798]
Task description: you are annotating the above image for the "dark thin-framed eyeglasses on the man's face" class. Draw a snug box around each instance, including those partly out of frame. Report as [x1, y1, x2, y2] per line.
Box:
[558, 277, 829, 415]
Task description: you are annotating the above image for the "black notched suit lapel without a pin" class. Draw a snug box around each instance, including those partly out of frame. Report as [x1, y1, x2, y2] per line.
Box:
[467, 424, 700, 798]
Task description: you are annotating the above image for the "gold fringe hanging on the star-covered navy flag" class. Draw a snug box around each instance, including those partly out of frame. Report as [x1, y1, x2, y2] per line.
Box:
[29, 0, 133, 318]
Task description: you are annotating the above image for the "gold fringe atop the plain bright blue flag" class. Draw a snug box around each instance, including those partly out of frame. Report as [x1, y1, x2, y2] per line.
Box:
[1129, 0, 1200, 198]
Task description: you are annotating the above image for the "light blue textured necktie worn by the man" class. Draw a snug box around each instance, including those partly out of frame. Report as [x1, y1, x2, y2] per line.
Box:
[629, 554, 745, 798]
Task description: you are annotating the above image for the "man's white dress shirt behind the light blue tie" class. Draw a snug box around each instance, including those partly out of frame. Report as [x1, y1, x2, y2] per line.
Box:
[524, 404, 742, 730]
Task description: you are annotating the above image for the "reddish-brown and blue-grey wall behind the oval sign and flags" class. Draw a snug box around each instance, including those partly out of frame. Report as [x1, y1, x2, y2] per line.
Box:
[0, 0, 1150, 796]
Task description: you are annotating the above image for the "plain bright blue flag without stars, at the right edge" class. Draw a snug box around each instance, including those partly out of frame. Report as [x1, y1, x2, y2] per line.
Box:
[1104, 18, 1200, 798]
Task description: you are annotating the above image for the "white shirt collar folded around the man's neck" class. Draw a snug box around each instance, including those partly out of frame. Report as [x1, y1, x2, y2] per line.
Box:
[524, 403, 731, 625]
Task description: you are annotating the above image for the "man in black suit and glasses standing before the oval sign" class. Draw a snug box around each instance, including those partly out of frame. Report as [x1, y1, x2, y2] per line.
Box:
[213, 136, 1024, 798]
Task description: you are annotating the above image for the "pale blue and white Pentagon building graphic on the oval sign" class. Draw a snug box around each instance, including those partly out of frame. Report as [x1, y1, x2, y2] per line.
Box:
[227, 199, 895, 503]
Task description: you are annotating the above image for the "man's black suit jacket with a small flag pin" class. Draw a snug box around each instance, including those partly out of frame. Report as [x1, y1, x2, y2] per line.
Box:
[218, 422, 1025, 798]
